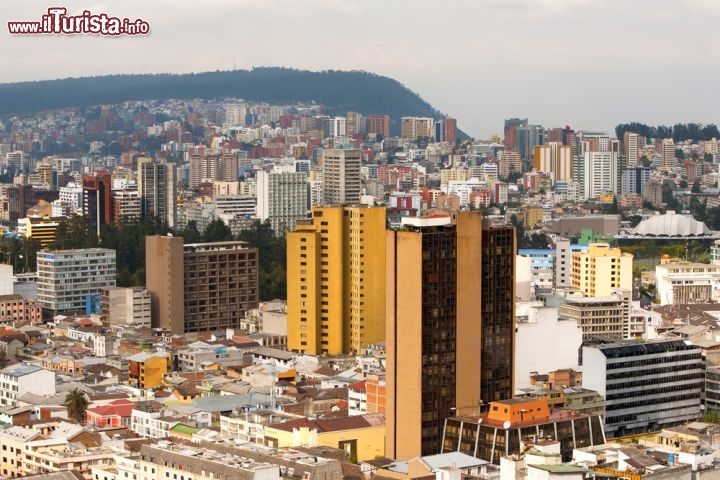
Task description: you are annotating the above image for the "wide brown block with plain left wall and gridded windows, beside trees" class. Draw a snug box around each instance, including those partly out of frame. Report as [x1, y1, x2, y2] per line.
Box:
[145, 235, 259, 334]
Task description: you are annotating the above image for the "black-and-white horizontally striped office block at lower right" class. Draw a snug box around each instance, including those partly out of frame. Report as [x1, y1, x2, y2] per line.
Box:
[582, 340, 704, 437]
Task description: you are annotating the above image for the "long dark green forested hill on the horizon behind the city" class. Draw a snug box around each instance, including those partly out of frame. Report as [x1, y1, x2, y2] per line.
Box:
[0, 67, 464, 136]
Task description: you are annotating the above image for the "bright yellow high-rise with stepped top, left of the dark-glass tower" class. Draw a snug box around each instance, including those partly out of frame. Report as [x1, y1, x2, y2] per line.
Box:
[287, 206, 385, 355]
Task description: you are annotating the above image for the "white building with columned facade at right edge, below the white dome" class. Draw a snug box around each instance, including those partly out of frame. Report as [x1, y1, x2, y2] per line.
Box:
[655, 259, 720, 305]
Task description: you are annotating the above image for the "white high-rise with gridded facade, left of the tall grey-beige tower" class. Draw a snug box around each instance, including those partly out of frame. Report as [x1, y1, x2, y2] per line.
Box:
[256, 170, 308, 235]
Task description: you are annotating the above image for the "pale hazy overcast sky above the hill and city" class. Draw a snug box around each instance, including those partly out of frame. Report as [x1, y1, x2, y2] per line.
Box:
[0, 0, 720, 138]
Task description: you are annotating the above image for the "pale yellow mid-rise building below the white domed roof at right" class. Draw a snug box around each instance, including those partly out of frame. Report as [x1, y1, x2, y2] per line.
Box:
[572, 243, 633, 297]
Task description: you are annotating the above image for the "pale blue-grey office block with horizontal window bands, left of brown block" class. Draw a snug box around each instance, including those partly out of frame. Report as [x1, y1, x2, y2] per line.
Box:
[37, 248, 116, 313]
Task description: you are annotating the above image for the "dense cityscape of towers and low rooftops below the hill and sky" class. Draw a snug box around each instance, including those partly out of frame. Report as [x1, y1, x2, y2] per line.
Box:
[0, 94, 720, 480]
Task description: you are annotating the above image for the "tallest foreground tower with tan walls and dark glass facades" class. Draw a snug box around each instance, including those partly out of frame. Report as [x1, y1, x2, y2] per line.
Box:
[386, 212, 515, 459]
